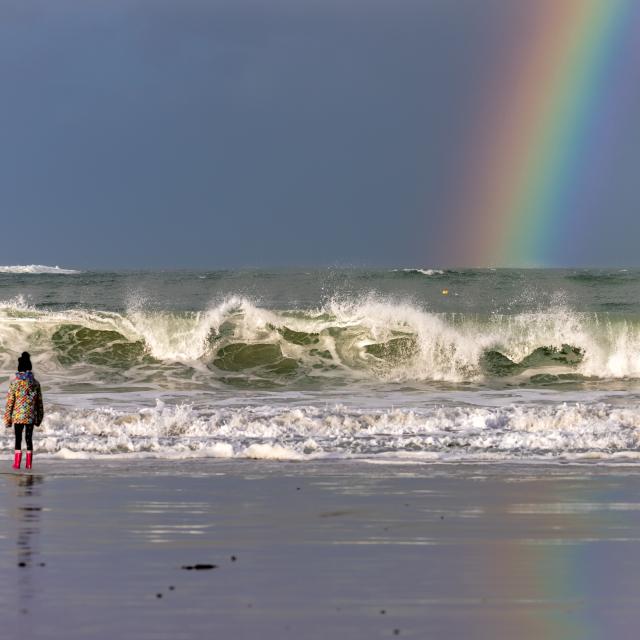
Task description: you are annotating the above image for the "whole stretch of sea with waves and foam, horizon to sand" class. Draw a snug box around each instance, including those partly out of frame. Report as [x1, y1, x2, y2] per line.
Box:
[0, 265, 640, 464]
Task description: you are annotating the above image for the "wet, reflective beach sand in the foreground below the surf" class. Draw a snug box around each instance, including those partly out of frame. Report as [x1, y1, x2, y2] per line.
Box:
[0, 458, 640, 640]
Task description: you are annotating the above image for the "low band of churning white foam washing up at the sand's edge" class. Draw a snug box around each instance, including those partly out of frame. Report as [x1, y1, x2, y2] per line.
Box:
[0, 401, 640, 461]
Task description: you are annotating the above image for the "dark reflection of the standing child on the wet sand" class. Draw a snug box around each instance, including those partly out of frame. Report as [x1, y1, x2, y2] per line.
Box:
[11, 474, 44, 614]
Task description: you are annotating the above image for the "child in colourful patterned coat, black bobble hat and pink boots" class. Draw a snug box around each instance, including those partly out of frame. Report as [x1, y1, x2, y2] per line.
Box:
[4, 351, 44, 469]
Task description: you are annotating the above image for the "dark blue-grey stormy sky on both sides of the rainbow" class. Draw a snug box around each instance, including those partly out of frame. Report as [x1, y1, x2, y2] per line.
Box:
[0, 0, 640, 268]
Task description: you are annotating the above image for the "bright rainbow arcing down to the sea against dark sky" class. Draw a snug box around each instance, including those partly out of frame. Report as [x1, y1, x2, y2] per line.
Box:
[452, 0, 640, 267]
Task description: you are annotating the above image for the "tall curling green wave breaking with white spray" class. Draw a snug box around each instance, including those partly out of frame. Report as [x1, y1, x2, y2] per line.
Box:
[0, 297, 640, 388]
